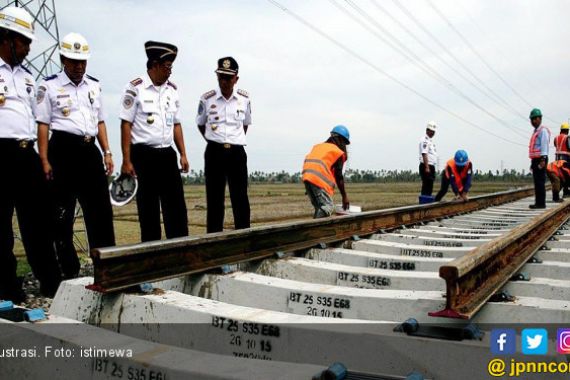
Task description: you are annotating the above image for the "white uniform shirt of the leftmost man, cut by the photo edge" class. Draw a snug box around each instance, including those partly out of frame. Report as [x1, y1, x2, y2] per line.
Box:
[0, 58, 37, 140]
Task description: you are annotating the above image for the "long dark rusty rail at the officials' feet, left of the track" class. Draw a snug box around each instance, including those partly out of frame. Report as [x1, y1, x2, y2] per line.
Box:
[90, 188, 534, 292]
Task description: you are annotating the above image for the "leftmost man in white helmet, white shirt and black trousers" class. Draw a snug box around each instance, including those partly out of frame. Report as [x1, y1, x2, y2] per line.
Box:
[0, 7, 61, 303]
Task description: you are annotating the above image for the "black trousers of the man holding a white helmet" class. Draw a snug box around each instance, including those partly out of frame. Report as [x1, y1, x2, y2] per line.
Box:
[131, 144, 188, 241]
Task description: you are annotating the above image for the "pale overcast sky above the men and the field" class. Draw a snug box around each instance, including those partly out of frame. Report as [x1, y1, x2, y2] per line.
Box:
[28, 0, 570, 171]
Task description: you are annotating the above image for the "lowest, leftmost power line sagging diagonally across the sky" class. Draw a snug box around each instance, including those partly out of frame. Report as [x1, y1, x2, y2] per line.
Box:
[267, 0, 526, 146]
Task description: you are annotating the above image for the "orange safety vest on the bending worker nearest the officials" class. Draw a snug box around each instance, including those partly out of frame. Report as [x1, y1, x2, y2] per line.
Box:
[302, 143, 346, 196]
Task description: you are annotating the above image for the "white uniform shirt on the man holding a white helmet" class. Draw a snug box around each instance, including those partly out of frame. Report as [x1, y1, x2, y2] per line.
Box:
[119, 74, 181, 148]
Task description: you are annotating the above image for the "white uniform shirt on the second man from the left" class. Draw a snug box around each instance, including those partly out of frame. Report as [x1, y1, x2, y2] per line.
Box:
[36, 71, 105, 136]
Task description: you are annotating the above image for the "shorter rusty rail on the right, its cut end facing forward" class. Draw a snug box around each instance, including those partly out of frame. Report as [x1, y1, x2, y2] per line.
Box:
[428, 202, 570, 319]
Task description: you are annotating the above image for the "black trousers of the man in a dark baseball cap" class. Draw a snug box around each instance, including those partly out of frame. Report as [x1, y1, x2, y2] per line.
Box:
[204, 141, 250, 233]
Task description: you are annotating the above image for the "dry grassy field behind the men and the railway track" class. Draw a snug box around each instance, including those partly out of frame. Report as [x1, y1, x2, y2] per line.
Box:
[14, 182, 529, 274]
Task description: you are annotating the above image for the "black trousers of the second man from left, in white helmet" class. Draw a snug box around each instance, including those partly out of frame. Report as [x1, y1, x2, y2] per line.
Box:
[48, 131, 115, 277]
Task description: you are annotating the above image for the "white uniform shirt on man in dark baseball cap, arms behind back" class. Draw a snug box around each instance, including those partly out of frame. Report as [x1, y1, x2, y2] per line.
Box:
[196, 89, 251, 145]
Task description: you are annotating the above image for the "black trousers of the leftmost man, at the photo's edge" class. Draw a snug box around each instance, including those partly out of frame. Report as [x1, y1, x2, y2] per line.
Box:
[0, 139, 61, 300]
